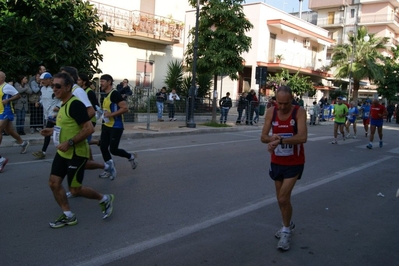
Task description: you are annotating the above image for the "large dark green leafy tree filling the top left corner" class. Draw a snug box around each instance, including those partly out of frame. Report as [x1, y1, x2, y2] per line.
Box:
[0, 0, 112, 80]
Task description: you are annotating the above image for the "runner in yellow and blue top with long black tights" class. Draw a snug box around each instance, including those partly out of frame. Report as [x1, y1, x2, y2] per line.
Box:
[100, 74, 138, 178]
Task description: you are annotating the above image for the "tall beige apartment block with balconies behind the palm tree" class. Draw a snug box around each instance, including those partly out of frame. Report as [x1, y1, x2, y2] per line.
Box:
[308, 0, 399, 98]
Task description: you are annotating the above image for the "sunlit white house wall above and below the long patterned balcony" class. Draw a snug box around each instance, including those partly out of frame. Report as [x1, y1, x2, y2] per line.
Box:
[91, 0, 191, 89]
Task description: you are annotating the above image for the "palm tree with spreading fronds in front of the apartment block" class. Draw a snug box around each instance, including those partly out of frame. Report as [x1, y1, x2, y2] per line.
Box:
[331, 27, 389, 101]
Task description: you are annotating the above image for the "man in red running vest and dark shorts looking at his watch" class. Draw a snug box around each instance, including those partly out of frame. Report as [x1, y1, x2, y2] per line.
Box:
[261, 86, 307, 250]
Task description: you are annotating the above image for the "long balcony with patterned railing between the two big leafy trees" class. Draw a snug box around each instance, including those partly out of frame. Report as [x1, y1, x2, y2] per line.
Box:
[90, 1, 184, 45]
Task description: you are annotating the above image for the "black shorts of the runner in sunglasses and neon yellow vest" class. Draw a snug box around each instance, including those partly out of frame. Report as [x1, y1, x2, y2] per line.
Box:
[51, 152, 87, 187]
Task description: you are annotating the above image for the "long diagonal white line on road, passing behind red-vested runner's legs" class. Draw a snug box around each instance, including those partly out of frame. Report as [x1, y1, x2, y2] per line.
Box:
[76, 156, 396, 266]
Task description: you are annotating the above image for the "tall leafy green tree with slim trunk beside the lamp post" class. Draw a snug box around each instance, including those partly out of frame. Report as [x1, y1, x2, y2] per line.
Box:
[185, 0, 253, 122]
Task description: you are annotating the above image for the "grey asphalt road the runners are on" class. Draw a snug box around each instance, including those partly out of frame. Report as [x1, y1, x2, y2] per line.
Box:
[0, 124, 399, 266]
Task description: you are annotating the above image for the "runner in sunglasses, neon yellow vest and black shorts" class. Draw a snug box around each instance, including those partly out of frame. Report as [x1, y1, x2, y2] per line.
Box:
[41, 73, 114, 228]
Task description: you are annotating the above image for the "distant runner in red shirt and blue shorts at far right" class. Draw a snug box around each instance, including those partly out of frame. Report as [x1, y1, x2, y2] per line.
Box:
[366, 99, 387, 149]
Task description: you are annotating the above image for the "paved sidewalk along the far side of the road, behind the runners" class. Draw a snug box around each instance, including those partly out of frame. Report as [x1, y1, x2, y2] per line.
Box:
[1, 120, 263, 147]
